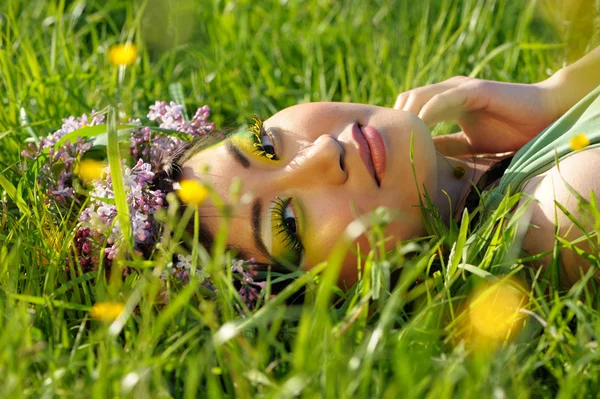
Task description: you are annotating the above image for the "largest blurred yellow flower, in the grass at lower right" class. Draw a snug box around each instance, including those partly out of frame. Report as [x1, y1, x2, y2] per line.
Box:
[464, 280, 527, 348]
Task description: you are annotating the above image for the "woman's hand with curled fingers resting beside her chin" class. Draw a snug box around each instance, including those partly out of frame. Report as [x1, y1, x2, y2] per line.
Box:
[394, 76, 561, 156]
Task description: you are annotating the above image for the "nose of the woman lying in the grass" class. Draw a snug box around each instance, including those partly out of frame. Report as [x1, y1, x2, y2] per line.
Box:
[286, 134, 348, 185]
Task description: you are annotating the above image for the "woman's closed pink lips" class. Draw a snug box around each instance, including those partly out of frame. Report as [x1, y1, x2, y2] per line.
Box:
[352, 123, 387, 187]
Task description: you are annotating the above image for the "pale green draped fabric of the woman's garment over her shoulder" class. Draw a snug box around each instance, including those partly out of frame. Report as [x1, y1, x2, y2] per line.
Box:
[486, 86, 600, 210]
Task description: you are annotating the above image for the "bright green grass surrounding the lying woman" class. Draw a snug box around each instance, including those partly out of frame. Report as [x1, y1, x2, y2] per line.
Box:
[0, 0, 600, 398]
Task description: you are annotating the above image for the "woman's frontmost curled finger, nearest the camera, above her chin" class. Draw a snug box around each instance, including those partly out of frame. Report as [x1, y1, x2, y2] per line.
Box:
[419, 81, 489, 126]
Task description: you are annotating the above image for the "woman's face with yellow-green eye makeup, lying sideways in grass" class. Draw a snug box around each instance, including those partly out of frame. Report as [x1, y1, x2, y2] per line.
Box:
[183, 103, 437, 283]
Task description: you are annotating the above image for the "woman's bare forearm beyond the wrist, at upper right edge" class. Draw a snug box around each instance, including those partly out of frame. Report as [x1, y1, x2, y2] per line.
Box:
[538, 47, 600, 116]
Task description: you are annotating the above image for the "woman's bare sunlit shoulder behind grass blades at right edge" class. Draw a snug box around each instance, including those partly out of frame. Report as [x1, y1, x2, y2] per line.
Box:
[522, 148, 600, 285]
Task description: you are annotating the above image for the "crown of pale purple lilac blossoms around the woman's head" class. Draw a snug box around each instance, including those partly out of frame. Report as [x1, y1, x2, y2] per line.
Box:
[22, 101, 262, 303]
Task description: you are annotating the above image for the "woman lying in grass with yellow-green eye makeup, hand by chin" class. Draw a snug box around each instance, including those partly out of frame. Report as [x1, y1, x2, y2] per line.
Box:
[168, 48, 600, 284]
